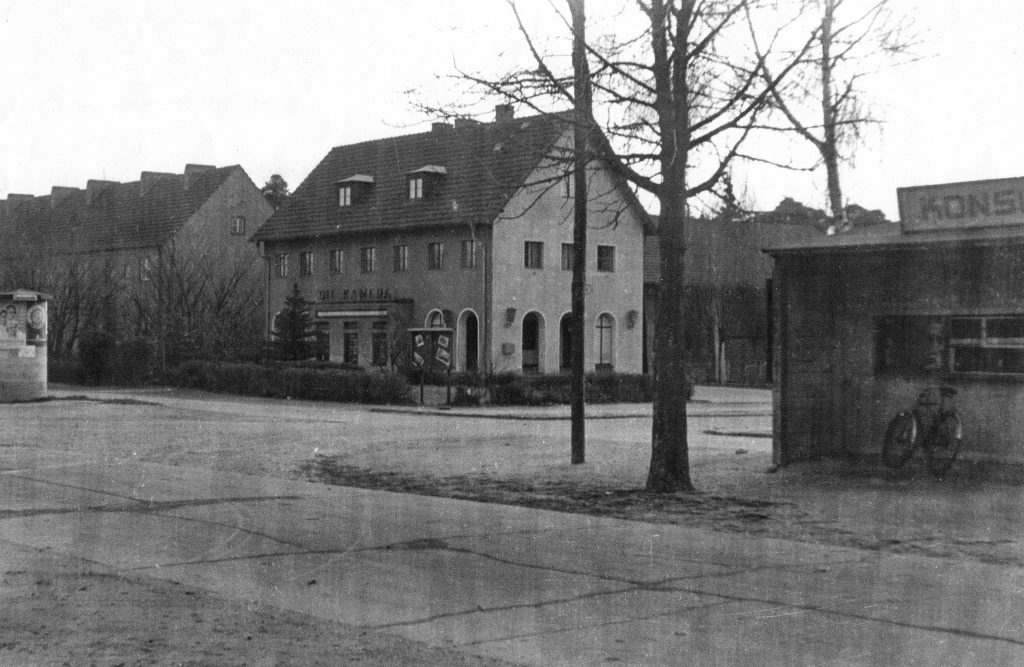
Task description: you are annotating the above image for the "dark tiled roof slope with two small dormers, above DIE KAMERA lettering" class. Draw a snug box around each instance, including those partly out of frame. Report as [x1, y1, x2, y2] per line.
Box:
[253, 115, 568, 241]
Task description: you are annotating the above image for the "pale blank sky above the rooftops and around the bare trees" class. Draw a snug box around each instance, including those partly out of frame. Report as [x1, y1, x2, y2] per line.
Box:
[0, 0, 1024, 219]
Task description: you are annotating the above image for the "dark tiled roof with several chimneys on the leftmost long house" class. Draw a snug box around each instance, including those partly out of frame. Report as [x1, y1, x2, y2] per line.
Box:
[0, 165, 235, 258]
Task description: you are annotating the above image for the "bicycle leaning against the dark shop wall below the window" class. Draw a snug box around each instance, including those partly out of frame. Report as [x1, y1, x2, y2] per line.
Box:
[882, 384, 964, 475]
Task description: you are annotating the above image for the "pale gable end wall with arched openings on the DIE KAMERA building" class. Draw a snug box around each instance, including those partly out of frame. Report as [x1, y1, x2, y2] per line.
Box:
[489, 134, 643, 373]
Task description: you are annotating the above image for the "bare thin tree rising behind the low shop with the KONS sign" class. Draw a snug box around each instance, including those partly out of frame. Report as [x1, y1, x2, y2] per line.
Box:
[752, 0, 916, 230]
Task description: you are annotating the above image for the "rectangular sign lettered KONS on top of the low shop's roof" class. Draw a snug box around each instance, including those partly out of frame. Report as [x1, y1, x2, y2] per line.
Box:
[896, 177, 1024, 232]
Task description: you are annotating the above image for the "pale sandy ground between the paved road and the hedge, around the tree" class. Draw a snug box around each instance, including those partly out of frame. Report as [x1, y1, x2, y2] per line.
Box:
[22, 388, 1024, 565]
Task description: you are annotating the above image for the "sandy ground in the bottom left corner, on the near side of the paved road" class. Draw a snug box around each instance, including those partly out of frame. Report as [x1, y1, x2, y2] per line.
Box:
[0, 545, 512, 665]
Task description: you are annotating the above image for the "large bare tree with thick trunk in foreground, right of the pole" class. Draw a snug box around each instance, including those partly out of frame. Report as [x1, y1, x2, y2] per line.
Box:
[428, 0, 811, 493]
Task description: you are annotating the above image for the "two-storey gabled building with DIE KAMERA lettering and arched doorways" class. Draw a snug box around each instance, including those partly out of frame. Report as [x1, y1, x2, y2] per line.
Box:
[253, 105, 649, 373]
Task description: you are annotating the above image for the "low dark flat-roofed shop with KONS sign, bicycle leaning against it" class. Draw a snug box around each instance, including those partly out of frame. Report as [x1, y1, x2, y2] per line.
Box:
[767, 178, 1024, 464]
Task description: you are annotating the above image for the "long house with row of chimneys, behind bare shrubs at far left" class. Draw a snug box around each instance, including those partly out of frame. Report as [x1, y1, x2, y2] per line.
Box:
[0, 164, 272, 350]
